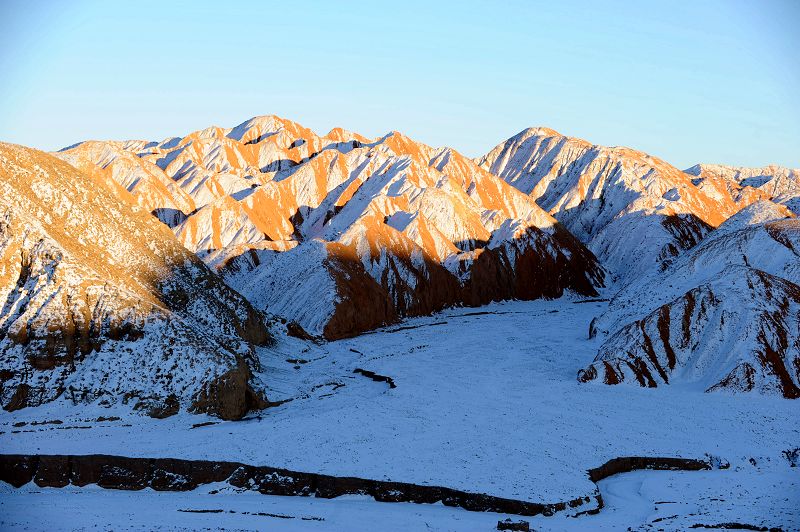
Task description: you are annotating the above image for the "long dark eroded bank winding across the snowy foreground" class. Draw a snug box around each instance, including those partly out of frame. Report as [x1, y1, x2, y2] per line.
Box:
[0, 454, 711, 516]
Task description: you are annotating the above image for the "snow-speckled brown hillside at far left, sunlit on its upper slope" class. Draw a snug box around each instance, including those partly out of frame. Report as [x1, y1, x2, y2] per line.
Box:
[0, 144, 270, 417]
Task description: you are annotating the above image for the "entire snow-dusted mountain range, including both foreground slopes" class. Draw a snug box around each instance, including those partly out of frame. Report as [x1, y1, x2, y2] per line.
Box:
[0, 116, 800, 419]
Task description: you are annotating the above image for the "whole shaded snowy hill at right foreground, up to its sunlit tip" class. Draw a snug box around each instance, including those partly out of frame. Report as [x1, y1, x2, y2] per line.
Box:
[579, 201, 800, 398]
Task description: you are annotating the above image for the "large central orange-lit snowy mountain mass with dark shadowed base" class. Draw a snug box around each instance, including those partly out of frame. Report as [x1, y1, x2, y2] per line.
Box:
[58, 116, 604, 339]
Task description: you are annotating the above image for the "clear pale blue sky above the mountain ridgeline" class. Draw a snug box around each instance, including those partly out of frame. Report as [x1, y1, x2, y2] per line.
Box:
[0, 0, 800, 167]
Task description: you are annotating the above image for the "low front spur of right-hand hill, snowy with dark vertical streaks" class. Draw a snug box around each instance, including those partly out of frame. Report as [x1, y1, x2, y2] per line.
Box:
[578, 266, 800, 399]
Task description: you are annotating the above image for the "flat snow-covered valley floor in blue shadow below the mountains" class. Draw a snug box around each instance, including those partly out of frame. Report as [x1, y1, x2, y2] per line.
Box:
[0, 298, 800, 530]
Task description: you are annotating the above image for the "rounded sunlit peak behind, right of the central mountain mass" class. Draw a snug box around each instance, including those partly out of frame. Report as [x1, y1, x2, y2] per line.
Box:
[478, 128, 744, 281]
